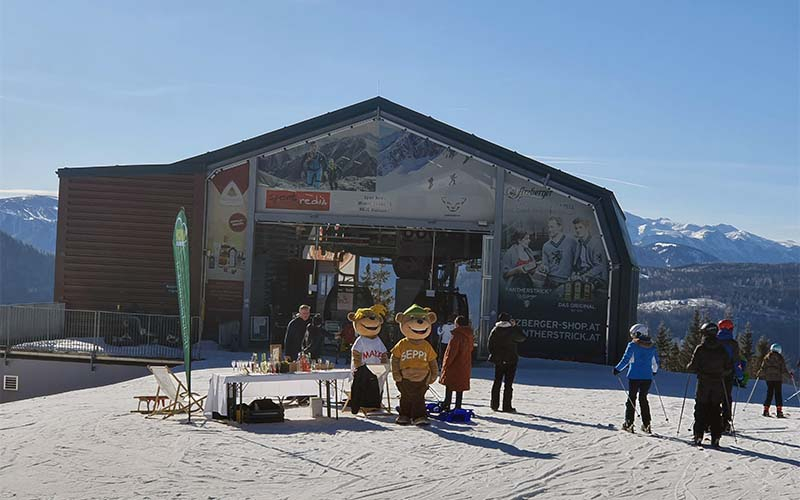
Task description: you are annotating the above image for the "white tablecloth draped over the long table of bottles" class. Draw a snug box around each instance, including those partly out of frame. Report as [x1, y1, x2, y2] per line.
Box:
[204, 369, 352, 418]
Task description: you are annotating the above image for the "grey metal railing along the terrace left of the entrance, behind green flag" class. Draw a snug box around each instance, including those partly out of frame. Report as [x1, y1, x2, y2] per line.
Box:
[0, 304, 201, 359]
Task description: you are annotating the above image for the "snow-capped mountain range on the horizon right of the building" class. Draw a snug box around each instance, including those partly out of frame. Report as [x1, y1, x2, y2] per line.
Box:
[625, 212, 800, 267]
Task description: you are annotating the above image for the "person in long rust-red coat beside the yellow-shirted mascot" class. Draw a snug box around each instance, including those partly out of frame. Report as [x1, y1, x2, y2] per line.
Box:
[439, 316, 473, 411]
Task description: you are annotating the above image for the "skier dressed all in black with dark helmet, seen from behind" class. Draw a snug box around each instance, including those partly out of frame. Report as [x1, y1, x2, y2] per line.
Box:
[686, 323, 733, 448]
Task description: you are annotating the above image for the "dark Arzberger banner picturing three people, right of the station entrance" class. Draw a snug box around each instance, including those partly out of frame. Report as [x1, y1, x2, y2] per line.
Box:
[499, 175, 608, 362]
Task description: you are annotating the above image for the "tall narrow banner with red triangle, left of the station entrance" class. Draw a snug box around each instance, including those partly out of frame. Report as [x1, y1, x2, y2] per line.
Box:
[206, 162, 250, 281]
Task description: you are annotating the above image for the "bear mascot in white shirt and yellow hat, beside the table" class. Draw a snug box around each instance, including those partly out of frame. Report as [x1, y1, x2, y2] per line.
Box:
[347, 304, 389, 414]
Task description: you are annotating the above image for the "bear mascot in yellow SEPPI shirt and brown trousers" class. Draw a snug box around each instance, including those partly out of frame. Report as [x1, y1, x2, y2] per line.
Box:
[392, 304, 439, 425]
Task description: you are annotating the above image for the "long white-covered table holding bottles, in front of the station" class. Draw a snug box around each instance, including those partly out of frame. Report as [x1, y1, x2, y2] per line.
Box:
[204, 369, 352, 419]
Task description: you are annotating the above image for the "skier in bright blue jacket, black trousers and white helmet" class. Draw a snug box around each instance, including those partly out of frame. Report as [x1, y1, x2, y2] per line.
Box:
[613, 323, 658, 434]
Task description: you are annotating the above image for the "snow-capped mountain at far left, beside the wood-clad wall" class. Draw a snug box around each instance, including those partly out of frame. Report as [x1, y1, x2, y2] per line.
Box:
[0, 196, 58, 254]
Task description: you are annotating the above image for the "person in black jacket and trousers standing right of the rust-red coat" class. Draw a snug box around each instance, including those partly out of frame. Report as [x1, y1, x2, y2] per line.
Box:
[489, 312, 526, 413]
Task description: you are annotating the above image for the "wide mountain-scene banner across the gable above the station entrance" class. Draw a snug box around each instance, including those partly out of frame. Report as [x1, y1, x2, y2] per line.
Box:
[256, 120, 495, 223]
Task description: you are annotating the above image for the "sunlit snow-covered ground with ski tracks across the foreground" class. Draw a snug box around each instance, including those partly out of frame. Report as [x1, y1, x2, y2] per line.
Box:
[0, 351, 800, 500]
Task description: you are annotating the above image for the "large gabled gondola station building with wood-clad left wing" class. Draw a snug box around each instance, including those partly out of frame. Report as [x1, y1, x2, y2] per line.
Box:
[55, 97, 638, 363]
